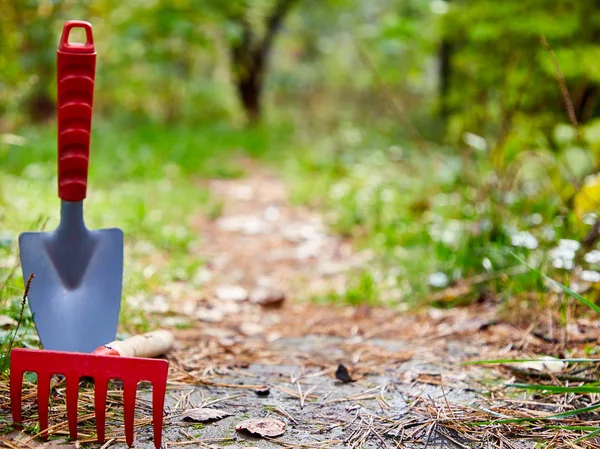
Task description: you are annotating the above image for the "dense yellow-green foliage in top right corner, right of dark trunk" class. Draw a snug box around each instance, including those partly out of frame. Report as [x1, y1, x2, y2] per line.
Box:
[441, 0, 600, 158]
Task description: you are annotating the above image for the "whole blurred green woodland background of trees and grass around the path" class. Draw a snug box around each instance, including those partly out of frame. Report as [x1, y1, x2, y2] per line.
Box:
[0, 0, 600, 317]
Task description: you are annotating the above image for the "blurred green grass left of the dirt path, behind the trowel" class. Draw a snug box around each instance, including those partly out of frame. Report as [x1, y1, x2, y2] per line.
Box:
[0, 116, 287, 372]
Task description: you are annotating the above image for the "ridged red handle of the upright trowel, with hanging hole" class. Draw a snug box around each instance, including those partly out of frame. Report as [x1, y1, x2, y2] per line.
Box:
[57, 20, 96, 201]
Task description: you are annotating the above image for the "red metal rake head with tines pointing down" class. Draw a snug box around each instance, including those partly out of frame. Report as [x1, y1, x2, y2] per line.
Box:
[10, 349, 169, 449]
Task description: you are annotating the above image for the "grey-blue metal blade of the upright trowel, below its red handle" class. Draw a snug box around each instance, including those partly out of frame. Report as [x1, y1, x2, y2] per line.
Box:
[19, 228, 123, 353]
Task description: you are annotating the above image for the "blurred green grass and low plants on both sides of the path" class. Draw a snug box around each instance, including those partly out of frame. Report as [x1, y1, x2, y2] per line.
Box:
[0, 114, 600, 362]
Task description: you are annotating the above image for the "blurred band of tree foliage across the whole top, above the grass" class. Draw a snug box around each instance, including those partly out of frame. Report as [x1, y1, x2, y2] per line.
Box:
[0, 0, 600, 138]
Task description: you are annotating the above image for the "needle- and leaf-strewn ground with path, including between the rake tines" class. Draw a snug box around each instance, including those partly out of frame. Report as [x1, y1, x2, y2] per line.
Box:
[0, 163, 600, 448]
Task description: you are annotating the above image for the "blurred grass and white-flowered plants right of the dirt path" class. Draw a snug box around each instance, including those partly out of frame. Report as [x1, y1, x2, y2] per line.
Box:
[276, 124, 599, 307]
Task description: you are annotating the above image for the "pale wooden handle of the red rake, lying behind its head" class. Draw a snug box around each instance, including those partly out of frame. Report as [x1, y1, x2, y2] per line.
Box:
[94, 329, 175, 358]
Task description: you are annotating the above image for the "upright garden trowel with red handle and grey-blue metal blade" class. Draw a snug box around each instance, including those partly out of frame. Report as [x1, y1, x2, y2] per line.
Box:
[19, 21, 123, 352]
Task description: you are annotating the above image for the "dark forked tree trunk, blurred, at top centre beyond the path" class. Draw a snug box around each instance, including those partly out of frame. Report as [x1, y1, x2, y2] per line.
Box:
[231, 0, 298, 124]
